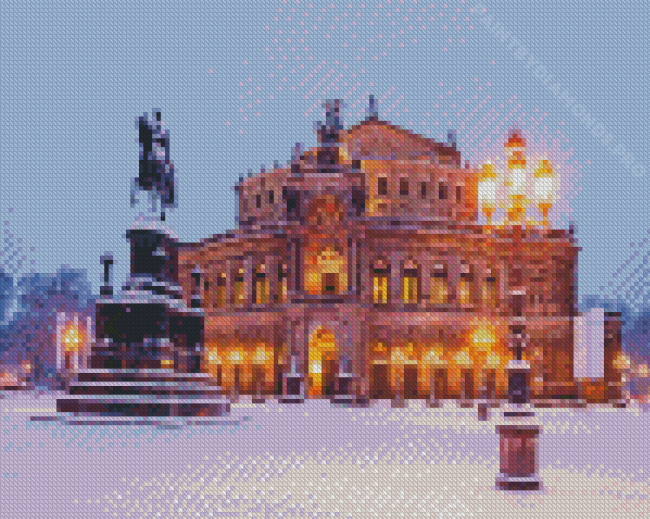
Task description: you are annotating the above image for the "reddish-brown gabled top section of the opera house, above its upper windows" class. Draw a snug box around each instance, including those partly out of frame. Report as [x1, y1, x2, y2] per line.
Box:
[341, 117, 461, 167]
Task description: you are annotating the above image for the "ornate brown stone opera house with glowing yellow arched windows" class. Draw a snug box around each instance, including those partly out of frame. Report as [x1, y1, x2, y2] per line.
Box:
[178, 107, 620, 401]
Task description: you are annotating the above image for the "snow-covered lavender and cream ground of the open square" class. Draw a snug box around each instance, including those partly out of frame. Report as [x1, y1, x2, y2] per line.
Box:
[0, 393, 650, 519]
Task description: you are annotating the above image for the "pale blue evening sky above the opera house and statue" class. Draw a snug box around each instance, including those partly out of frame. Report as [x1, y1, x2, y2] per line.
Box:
[0, 0, 650, 303]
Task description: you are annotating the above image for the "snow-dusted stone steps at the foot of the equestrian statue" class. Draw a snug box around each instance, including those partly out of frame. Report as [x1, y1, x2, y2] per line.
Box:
[56, 369, 230, 417]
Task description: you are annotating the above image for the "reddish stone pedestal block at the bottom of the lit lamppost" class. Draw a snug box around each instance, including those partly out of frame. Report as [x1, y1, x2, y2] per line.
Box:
[496, 424, 541, 490]
